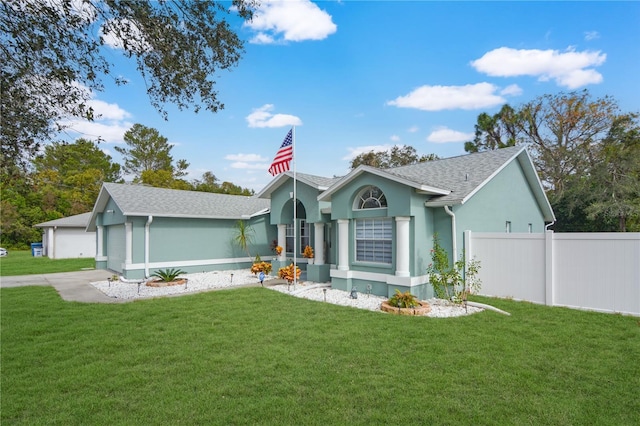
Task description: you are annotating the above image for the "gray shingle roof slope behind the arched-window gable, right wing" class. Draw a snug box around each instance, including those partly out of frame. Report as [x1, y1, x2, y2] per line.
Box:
[384, 146, 524, 204]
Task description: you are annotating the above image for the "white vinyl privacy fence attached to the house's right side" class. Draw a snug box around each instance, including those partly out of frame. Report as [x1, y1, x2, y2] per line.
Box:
[464, 231, 640, 316]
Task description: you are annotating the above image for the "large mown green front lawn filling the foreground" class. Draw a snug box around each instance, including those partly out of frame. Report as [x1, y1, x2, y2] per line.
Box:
[0, 287, 640, 425]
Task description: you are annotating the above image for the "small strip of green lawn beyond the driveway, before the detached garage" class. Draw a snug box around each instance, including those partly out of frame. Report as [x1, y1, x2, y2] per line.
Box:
[0, 250, 96, 277]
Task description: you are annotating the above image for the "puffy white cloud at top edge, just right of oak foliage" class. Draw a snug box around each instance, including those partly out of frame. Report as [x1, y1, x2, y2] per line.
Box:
[244, 0, 337, 44]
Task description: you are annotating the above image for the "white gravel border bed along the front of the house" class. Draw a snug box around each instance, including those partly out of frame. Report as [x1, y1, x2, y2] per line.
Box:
[91, 270, 484, 318]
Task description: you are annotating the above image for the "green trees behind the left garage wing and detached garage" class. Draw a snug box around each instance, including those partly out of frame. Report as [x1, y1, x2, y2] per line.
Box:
[0, 124, 254, 248]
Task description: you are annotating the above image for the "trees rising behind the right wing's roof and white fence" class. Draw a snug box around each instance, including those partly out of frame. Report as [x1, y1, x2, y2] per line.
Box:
[351, 90, 640, 232]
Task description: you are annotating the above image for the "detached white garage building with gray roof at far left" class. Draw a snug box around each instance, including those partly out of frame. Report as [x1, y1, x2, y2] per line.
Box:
[35, 212, 96, 259]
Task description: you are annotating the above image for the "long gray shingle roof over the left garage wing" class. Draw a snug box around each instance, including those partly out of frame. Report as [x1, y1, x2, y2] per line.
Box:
[103, 183, 269, 219]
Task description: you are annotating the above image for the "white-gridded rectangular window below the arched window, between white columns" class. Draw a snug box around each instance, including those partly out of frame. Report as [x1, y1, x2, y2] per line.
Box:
[355, 218, 392, 264]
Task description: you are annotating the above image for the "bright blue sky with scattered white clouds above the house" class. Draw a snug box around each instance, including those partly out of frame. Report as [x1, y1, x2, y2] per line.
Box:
[64, 0, 640, 191]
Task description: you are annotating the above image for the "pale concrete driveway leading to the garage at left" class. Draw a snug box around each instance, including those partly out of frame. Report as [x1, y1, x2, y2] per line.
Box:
[0, 269, 128, 303]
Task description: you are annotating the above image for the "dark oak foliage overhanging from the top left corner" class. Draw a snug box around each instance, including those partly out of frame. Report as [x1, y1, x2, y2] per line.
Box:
[0, 0, 257, 167]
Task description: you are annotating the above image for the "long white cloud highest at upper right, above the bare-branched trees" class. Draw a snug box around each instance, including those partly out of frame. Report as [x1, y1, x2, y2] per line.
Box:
[471, 47, 607, 89]
